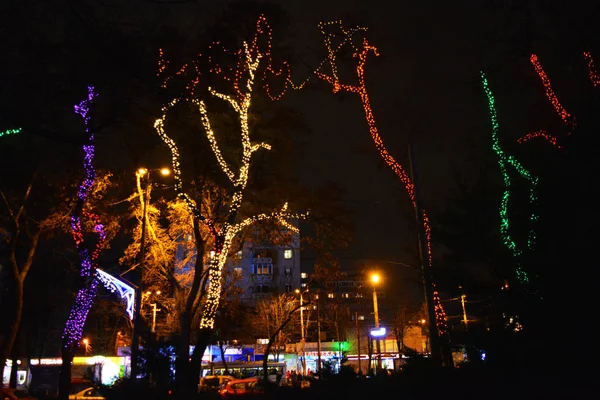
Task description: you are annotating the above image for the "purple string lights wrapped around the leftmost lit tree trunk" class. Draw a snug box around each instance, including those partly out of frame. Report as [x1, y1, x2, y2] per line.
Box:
[63, 86, 106, 347]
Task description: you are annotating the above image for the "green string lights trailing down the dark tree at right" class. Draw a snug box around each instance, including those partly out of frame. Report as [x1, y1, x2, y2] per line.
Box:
[481, 71, 538, 283]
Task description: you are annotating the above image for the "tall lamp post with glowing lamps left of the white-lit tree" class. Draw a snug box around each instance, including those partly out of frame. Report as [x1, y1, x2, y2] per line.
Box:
[130, 168, 171, 381]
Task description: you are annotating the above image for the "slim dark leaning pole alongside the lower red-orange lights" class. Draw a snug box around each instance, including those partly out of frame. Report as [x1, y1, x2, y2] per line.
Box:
[408, 142, 442, 365]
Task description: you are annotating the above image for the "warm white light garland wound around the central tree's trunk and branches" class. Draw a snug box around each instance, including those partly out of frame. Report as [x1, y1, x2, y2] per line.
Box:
[154, 16, 307, 329]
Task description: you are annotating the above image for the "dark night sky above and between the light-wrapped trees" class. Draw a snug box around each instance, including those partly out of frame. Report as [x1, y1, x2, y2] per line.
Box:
[0, 0, 595, 296]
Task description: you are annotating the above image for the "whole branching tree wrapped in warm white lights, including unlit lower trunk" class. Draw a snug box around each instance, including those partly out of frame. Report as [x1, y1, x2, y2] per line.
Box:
[155, 16, 305, 390]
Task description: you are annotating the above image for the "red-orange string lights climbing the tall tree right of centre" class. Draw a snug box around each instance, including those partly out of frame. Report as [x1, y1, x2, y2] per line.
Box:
[315, 21, 446, 329]
